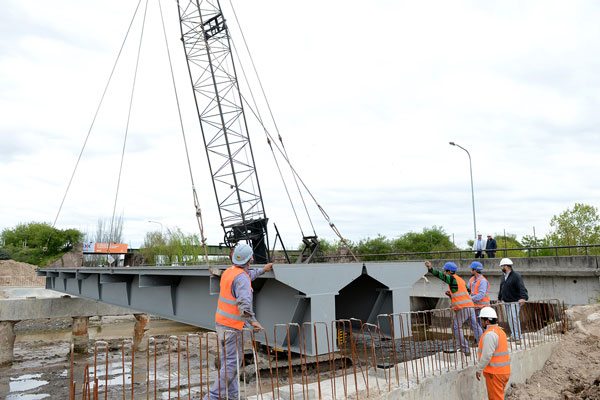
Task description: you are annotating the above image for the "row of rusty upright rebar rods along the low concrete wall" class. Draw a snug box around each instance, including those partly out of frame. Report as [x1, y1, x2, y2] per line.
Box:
[69, 300, 568, 400]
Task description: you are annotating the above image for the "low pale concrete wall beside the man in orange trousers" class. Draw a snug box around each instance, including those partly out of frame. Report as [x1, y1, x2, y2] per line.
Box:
[379, 342, 558, 400]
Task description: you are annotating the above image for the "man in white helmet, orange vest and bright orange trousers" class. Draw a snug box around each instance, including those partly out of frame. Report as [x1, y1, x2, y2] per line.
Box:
[475, 307, 510, 400]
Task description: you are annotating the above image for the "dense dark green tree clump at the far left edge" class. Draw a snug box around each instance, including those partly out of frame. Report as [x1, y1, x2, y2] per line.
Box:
[1, 222, 83, 266]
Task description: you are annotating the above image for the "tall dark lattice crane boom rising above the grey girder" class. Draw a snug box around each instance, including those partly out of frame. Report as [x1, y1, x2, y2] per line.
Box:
[177, 0, 270, 264]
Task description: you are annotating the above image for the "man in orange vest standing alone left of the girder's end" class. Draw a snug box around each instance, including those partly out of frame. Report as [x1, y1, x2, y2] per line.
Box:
[204, 243, 273, 400]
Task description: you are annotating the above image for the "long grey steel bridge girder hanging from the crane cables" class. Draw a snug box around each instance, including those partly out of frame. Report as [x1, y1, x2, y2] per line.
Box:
[38, 262, 424, 355]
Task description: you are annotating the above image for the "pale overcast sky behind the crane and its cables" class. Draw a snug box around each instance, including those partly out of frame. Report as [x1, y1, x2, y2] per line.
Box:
[0, 0, 600, 247]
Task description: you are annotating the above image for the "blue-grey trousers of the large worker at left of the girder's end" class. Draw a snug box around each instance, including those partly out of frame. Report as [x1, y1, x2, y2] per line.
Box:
[203, 325, 243, 400]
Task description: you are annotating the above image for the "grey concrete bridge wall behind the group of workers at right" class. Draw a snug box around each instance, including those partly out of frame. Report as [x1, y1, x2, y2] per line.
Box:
[411, 256, 600, 305]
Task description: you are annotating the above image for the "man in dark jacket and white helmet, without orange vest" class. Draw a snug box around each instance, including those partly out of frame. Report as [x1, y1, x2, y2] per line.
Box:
[498, 258, 529, 344]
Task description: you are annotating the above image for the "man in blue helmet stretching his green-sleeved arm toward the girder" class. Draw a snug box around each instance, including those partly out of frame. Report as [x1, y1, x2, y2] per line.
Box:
[425, 261, 482, 356]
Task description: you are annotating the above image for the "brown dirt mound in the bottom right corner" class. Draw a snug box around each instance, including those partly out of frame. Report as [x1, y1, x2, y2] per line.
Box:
[506, 304, 600, 400]
